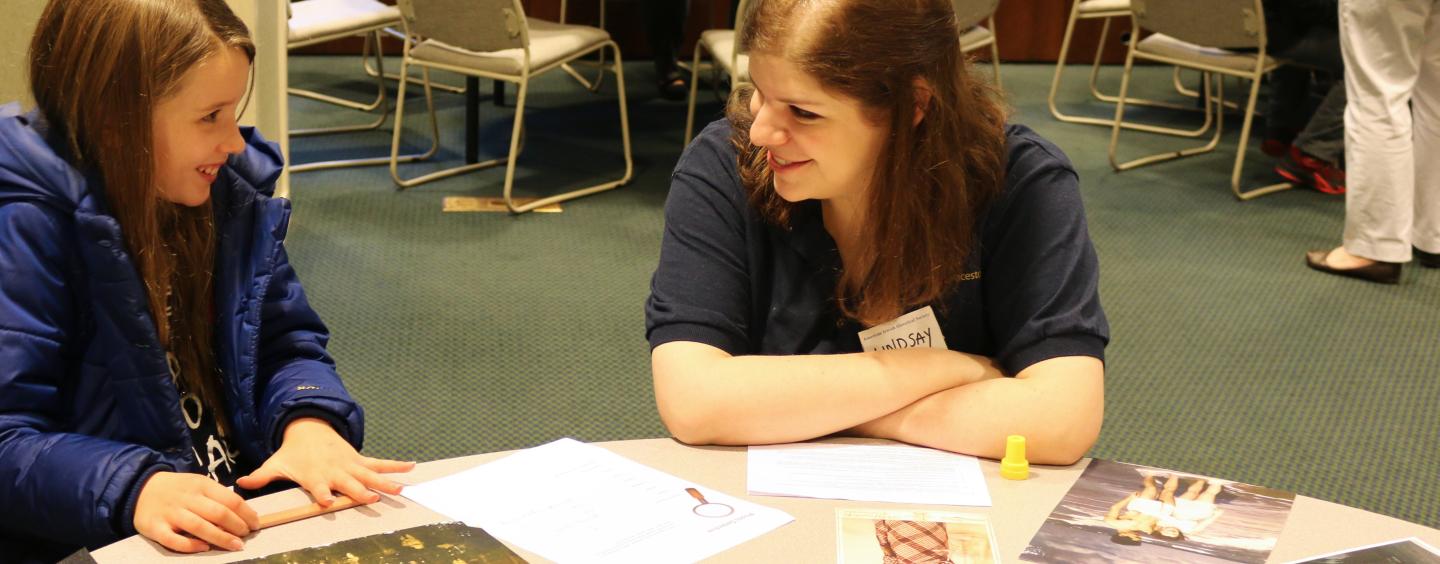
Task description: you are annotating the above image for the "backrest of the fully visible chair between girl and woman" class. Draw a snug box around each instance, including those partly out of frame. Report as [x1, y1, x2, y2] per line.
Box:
[399, 0, 530, 52]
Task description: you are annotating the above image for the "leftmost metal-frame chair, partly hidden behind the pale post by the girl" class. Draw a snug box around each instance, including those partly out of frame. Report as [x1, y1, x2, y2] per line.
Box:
[287, 0, 436, 173]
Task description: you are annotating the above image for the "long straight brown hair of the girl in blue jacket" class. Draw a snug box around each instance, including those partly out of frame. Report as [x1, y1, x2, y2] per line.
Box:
[29, 0, 255, 433]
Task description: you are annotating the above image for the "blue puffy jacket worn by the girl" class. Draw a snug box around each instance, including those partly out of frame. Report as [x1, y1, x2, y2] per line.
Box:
[0, 104, 364, 561]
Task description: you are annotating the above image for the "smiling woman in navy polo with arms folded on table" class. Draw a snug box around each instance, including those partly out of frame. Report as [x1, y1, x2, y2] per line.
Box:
[647, 0, 1109, 463]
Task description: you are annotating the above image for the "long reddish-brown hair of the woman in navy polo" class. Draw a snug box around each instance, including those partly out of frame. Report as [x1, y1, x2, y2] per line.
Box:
[726, 0, 1007, 325]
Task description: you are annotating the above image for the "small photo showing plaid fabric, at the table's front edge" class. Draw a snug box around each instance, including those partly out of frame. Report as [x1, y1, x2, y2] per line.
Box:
[835, 509, 999, 564]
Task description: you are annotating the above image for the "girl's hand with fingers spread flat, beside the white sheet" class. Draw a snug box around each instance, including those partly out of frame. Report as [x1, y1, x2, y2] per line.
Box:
[235, 417, 415, 506]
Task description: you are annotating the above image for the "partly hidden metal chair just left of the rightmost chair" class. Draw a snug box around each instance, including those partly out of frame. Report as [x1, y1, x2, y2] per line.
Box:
[1047, 0, 1212, 137]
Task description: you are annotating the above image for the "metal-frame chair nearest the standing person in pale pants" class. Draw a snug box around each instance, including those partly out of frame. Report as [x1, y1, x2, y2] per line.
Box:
[1109, 0, 1292, 200]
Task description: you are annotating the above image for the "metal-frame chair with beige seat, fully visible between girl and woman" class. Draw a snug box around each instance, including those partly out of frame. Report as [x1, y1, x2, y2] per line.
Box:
[390, 0, 634, 213]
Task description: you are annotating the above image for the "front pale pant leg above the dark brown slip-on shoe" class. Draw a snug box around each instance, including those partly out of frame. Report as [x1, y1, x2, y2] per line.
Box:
[1339, 0, 1437, 262]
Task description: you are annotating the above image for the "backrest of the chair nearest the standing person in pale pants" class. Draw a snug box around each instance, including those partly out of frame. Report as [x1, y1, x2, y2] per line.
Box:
[1130, 0, 1266, 49]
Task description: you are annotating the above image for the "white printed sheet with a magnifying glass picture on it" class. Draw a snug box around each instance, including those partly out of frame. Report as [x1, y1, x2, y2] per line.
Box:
[403, 439, 795, 563]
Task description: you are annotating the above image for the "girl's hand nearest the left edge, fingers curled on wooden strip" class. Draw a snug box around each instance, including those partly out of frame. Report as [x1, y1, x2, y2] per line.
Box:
[134, 472, 259, 552]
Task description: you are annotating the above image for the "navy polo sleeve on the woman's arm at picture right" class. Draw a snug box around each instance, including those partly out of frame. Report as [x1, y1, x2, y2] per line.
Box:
[981, 125, 1110, 374]
